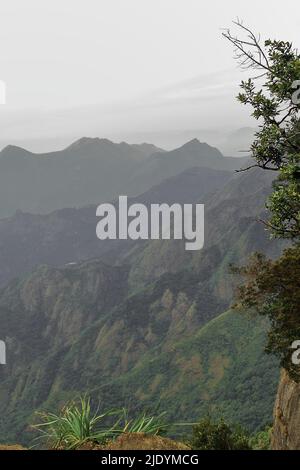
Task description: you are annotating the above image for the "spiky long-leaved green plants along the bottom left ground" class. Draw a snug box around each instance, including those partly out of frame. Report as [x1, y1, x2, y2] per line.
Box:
[33, 397, 168, 450]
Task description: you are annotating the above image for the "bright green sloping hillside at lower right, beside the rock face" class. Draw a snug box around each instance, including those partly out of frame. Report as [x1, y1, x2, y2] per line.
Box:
[100, 311, 279, 432]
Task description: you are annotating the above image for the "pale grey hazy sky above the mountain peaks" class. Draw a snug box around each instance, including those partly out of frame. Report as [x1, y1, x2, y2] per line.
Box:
[0, 0, 300, 149]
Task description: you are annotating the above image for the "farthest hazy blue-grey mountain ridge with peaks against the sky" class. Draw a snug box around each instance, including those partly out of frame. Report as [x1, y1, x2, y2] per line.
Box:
[0, 138, 244, 218]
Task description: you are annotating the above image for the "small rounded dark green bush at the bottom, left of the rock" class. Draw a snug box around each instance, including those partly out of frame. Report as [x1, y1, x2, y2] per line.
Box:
[190, 416, 251, 450]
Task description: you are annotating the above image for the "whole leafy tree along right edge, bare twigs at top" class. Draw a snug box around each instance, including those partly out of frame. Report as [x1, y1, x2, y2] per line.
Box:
[223, 21, 300, 381]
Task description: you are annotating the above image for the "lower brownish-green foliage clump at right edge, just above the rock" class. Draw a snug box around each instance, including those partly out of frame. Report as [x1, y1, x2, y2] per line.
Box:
[237, 244, 300, 381]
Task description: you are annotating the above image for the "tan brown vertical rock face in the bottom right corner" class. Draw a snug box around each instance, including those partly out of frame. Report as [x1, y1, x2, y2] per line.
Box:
[272, 370, 300, 450]
